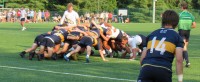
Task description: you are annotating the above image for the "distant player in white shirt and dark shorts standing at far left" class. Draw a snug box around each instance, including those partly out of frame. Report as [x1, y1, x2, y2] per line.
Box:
[20, 7, 27, 31]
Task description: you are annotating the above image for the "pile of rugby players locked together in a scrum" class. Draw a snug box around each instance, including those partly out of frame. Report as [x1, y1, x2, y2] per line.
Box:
[19, 21, 146, 63]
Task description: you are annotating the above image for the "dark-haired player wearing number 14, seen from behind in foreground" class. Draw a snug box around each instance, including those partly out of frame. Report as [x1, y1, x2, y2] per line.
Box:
[138, 10, 184, 82]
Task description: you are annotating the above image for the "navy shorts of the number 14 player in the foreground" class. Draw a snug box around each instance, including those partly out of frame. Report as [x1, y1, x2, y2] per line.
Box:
[137, 66, 172, 82]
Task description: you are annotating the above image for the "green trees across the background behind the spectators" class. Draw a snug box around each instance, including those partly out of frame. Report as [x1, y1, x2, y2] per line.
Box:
[0, 0, 200, 22]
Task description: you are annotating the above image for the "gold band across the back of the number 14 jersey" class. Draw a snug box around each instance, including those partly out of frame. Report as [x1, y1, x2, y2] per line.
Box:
[147, 40, 176, 53]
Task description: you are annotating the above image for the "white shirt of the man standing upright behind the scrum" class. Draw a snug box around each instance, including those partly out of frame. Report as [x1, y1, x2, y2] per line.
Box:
[60, 11, 79, 25]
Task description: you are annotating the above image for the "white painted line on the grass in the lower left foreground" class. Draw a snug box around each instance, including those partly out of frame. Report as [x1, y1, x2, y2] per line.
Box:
[0, 66, 136, 82]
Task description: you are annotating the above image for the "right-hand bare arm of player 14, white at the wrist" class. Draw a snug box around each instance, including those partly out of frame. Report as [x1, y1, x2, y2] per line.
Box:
[176, 47, 183, 82]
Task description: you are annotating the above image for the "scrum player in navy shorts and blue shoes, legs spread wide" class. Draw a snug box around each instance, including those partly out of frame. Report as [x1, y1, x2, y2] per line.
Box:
[64, 21, 107, 63]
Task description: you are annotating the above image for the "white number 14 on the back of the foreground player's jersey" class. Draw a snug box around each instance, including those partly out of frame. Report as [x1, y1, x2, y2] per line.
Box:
[150, 37, 166, 55]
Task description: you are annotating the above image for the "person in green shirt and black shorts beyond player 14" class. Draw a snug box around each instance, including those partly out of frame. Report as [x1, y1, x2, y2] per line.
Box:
[178, 2, 196, 67]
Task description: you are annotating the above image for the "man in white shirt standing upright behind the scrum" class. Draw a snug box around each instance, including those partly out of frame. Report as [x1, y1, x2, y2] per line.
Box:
[60, 3, 80, 25]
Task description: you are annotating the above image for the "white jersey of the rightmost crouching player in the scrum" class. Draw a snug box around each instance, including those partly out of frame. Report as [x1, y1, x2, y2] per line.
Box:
[128, 35, 142, 49]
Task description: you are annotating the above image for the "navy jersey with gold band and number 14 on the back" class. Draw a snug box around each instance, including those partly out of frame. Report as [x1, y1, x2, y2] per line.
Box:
[142, 28, 183, 71]
